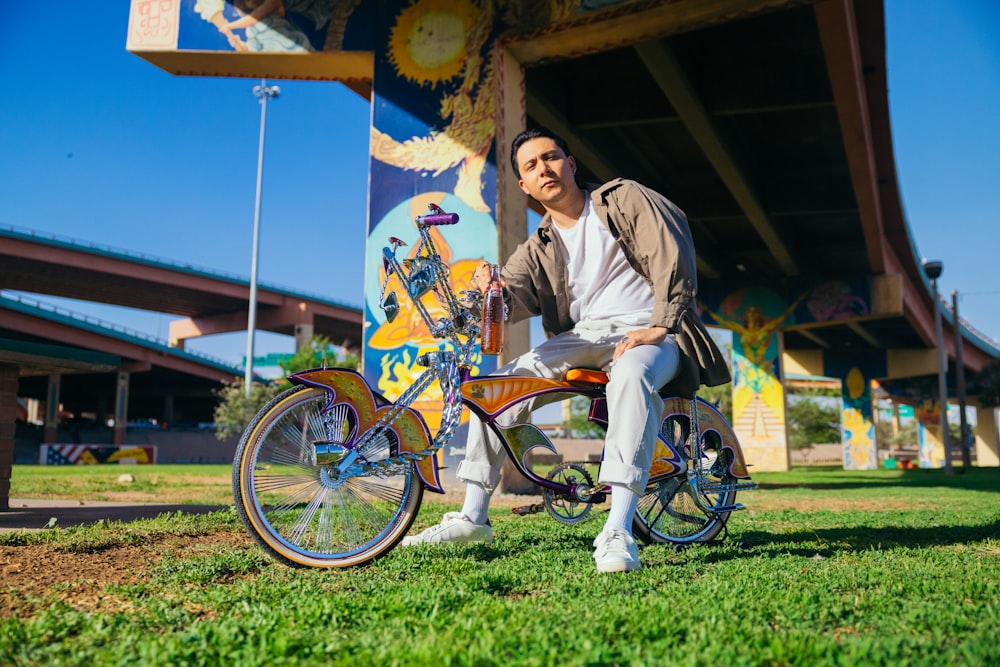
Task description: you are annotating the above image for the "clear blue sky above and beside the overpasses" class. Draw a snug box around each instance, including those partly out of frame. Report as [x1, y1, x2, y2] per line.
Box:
[0, 0, 1000, 370]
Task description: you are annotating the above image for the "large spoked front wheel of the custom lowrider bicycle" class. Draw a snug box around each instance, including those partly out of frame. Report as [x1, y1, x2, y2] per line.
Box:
[233, 387, 423, 568]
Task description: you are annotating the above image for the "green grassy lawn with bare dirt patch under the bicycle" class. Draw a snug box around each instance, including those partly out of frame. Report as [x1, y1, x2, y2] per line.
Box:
[0, 466, 1000, 666]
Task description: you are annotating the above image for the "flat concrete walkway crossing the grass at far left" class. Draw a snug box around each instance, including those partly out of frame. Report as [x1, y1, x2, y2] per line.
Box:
[0, 498, 225, 533]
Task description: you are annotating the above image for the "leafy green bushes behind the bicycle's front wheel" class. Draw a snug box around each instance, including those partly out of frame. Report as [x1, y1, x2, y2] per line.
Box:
[214, 336, 360, 440]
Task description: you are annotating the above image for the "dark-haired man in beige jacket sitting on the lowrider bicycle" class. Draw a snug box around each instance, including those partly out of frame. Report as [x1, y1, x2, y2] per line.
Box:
[403, 129, 730, 572]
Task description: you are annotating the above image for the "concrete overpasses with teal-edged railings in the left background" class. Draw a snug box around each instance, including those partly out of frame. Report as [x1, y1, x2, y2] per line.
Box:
[0, 228, 361, 509]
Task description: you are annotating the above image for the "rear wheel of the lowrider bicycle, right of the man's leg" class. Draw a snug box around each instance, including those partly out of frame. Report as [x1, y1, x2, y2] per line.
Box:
[632, 414, 737, 545]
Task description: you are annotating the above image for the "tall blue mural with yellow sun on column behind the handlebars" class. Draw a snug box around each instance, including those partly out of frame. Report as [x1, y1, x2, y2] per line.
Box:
[364, 0, 508, 428]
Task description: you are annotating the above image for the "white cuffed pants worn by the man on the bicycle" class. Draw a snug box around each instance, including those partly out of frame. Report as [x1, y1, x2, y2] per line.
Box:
[457, 322, 680, 495]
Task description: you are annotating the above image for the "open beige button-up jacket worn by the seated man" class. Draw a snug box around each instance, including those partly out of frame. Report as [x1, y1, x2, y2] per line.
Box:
[502, 178, 730, 397]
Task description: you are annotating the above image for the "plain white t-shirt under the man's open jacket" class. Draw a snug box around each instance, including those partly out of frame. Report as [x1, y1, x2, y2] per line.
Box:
[552, 198, 655, 325]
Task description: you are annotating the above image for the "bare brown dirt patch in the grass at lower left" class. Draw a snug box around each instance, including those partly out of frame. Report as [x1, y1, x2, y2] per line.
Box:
[0, 533, 251, 618]
